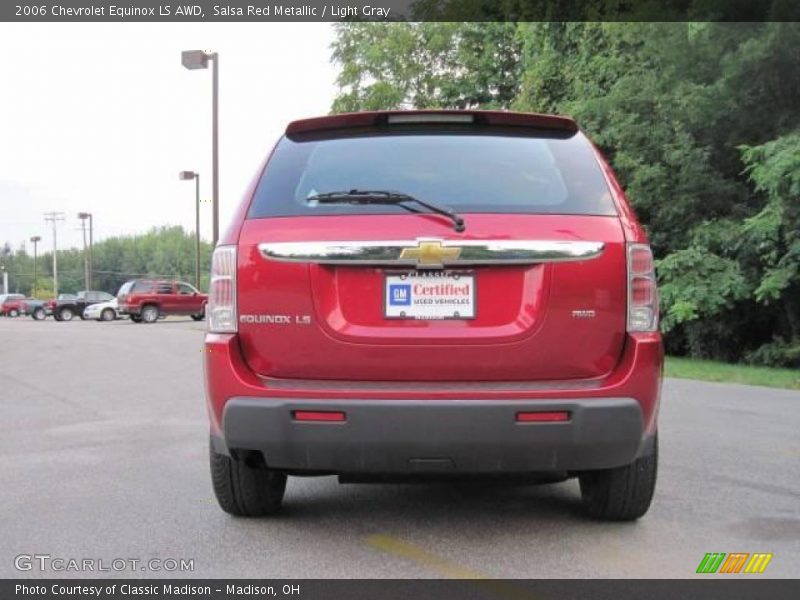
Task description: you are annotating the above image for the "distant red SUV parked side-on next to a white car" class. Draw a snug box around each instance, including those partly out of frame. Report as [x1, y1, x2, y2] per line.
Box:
[117, 279, 208, 323]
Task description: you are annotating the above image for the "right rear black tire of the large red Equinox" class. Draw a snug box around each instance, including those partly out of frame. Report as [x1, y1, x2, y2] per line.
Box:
[580, 435, 658, 521]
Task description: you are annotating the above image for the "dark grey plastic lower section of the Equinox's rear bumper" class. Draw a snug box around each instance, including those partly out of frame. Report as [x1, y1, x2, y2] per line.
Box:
[215, 398, 646, 474]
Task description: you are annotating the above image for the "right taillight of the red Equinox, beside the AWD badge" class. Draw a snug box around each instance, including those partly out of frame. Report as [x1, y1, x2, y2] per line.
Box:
[628, 244, 658, 331]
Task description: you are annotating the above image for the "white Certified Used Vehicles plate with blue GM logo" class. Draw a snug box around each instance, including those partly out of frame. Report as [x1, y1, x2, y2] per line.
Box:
[383, 271, 475, 320]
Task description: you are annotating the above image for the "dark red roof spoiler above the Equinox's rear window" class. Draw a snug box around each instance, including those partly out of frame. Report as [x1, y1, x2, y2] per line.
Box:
[286, 110, 578, 135]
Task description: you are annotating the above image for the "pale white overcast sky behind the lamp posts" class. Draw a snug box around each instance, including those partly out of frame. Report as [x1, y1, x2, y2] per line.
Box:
[0, 23, 336, 252]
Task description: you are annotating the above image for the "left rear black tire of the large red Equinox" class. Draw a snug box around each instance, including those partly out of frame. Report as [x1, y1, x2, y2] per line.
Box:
[209, 444, 286, 517]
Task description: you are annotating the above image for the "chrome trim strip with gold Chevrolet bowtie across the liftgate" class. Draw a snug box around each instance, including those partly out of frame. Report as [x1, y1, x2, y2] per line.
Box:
[258, 238, 605, 269]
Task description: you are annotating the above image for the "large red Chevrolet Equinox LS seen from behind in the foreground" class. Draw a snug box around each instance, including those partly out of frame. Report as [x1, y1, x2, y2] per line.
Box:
[203, 111, 662, 520]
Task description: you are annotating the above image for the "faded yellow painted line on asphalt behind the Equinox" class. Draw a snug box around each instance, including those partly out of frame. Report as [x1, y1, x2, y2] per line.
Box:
[364, 534, 535, 600]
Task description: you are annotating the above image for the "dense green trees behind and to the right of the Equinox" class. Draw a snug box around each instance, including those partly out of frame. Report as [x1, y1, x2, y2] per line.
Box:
[333, 17, 800, 364]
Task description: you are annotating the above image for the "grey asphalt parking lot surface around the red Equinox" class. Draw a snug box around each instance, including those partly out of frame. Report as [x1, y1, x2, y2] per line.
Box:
[0, 318, 800, 578]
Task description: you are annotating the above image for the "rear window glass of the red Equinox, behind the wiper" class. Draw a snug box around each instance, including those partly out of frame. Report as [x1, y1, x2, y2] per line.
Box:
[248, 128, 616, 218]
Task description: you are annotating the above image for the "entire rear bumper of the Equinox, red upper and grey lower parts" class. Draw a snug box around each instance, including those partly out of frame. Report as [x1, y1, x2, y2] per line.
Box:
[203, 333, 663, 474]
